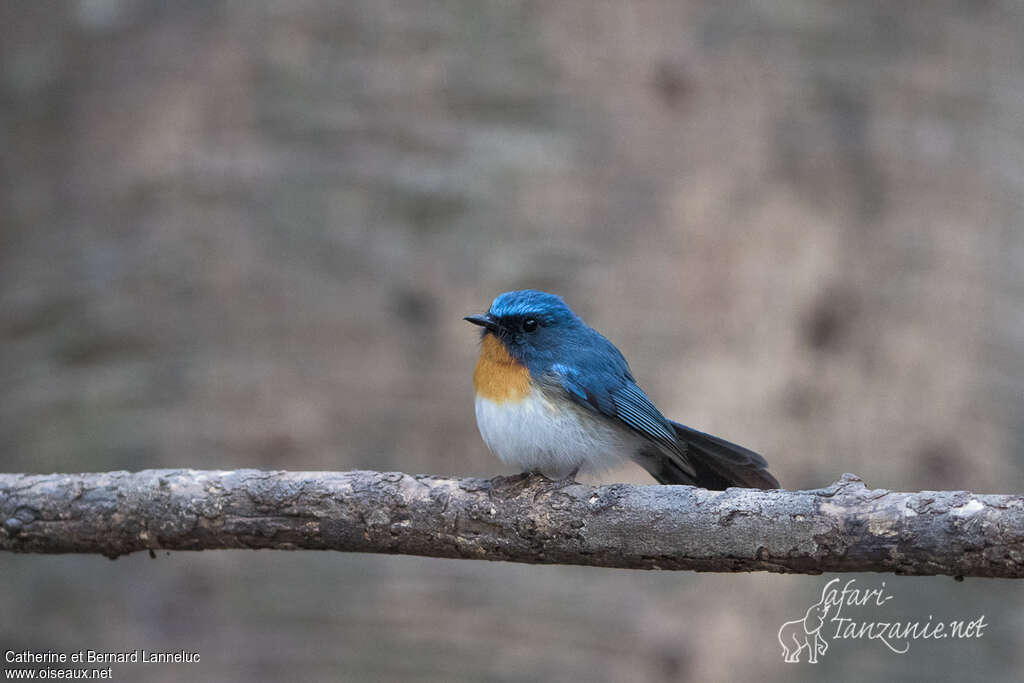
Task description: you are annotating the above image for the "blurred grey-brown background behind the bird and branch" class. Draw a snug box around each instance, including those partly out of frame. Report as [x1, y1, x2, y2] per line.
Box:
[0, 0, 1024, 681]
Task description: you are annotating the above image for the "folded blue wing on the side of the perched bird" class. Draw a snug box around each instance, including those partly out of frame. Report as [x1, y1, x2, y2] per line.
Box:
[551, 361, 694, 475]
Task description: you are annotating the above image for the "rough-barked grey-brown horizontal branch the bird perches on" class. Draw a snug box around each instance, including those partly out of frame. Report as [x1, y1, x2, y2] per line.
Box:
[0, 470, 1024, 578]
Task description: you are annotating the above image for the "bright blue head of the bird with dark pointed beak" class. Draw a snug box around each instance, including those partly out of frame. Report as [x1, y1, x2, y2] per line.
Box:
[463, 290, 583, 365]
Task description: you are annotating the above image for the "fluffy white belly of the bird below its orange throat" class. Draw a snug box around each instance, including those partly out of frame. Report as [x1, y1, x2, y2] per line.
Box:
[476, 390, 639, 479]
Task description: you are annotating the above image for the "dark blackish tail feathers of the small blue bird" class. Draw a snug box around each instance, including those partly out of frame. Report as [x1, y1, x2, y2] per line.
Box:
[642, 422, 779, 490]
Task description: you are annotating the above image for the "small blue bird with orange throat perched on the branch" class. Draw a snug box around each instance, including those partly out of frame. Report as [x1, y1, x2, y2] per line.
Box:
[463, 290, 779, 490]
